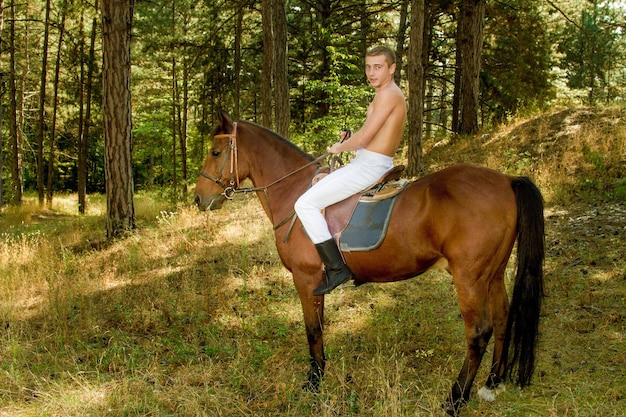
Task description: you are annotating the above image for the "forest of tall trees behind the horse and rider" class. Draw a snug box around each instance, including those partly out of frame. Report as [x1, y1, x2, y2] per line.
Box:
[0, 0, 626, 231]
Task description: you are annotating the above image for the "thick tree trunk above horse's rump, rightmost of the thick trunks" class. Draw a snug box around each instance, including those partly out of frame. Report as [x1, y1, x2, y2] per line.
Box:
[457, 0, 485, 134]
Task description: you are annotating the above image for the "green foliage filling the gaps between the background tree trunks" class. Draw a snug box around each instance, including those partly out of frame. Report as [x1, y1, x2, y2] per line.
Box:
[0, 0, 626, 206]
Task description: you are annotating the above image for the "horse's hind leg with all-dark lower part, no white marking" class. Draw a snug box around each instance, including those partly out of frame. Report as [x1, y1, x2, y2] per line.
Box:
[445, 286, 492, 416]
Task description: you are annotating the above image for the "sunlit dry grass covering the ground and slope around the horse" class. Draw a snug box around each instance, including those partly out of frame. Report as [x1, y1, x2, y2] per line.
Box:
[0, 108, 626, 417]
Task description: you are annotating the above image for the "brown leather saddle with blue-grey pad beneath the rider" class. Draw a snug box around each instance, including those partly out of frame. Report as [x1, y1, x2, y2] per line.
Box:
[314, 165, 409, 251]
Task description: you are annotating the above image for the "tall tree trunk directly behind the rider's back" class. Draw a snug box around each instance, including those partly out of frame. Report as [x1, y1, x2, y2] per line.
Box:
[407, 0, 424, 176]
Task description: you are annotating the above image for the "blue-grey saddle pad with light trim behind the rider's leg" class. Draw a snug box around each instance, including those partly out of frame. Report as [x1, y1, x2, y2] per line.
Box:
[339, 196, 398, 252]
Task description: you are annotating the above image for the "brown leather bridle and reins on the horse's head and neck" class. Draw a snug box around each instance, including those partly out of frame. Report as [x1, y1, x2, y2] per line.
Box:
[200, 122, 330, 236]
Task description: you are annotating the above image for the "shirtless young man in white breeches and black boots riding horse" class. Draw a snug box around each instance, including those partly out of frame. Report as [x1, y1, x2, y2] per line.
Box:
[295, 46, 406, 295]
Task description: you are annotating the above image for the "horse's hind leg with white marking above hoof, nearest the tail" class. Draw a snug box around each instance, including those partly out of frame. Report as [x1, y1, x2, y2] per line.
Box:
[478, 275, 509, 401]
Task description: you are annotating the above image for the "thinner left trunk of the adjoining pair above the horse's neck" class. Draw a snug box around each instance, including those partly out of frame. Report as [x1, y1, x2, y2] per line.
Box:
[261, 0, 274, 129]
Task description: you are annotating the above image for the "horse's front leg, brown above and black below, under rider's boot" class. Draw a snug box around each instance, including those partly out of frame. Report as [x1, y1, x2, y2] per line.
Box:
[293, 270, 326, 392]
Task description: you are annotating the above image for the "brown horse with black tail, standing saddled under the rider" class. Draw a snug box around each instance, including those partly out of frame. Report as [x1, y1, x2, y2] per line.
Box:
[195, 113, 544, 415]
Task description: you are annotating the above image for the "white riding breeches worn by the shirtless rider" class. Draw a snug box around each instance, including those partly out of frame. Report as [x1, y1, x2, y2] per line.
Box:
[294, 149, 393, 244]
